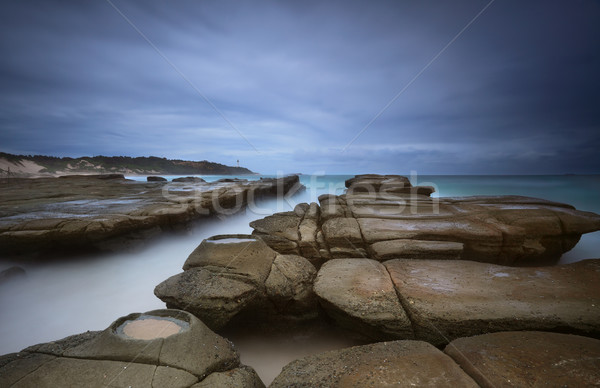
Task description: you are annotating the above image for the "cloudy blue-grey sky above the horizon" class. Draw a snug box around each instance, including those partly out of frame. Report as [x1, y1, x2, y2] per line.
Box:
[0, 0, 600, 174]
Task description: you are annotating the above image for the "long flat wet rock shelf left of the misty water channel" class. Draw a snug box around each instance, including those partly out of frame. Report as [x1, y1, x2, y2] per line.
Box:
[0, 175, 300, 254]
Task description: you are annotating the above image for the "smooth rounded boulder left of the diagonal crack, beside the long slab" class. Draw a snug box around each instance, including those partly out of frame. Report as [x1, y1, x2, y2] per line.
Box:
[314, 259, 413, 339]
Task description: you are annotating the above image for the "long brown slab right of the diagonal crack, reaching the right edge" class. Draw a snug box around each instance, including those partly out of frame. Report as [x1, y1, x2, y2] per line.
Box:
[384, 260, 600, 345]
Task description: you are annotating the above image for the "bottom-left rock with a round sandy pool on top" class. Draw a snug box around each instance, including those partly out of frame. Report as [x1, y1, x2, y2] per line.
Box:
[0, 310, 264, 387]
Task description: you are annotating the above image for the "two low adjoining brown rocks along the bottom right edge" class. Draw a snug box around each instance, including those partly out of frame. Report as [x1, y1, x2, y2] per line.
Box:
[270, 332, 600, 388]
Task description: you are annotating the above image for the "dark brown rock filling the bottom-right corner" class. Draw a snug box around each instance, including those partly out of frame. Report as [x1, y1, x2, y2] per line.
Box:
[444, 331, 600, 388]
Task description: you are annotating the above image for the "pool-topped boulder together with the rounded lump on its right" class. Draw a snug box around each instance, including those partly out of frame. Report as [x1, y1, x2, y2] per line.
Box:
[154, 235, 317, 330]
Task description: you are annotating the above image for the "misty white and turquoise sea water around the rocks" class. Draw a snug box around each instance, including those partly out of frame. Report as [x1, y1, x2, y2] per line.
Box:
[0, 173, 600, 384]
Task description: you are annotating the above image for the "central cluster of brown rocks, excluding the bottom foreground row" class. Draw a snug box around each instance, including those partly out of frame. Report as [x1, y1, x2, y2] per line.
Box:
[155, 175, 600, 346]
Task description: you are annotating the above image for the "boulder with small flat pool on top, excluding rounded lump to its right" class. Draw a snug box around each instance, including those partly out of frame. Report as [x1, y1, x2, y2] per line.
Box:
[154, 235, 284, 330]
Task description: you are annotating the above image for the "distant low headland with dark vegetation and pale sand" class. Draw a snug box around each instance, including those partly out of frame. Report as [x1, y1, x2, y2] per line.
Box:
[0, 152, 254, 175]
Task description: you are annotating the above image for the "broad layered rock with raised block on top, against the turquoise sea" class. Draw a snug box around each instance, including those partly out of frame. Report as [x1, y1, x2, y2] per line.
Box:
[251, 174, 600, 266]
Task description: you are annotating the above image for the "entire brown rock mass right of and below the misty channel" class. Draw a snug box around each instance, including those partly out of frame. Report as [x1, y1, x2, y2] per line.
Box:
[0, 175, 600, 388]
